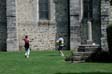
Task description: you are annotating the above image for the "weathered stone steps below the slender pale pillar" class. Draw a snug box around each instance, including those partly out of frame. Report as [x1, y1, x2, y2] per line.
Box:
[66, 44, 99, 62]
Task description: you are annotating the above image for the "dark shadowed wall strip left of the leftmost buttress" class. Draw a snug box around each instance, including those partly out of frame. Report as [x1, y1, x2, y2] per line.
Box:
[0, 0, 7, 51]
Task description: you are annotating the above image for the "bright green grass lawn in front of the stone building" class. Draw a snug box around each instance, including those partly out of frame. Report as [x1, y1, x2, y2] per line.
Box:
[0, 51, 112, 74]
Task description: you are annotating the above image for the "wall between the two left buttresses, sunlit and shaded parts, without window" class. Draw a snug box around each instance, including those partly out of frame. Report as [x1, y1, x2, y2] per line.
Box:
[16, 0, 68, 50]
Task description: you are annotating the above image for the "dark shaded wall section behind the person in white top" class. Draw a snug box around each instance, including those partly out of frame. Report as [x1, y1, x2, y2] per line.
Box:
[55, 0, 70, 50]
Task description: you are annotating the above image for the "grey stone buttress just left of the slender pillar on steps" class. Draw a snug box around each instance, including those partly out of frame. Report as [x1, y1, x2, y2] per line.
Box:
[70, 0, 81, 49]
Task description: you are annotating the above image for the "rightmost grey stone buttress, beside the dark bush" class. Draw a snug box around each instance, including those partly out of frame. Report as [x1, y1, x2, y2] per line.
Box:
[101, 0, 110, 51]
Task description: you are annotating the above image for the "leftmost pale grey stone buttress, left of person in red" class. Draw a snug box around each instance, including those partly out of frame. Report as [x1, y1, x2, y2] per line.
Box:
[6, 0, 19, 51]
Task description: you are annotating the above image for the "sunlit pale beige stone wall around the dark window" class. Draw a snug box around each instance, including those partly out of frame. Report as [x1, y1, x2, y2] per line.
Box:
[17, 0, 56, 50]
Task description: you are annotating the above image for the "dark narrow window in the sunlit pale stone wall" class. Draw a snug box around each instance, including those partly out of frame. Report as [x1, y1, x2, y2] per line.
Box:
[39, 0, 49, 20]
